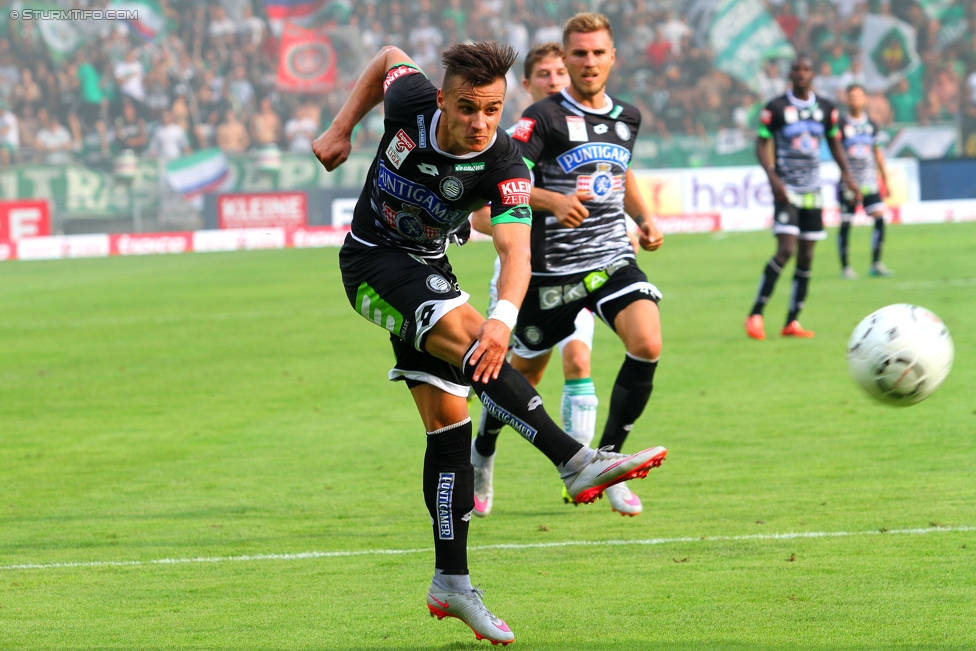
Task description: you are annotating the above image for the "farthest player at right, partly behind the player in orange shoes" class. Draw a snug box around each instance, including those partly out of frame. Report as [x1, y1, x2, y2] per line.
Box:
[837, 84, 892, 278]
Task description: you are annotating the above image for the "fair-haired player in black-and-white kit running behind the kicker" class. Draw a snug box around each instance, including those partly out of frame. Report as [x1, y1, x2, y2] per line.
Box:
[476, 13, 663, 515]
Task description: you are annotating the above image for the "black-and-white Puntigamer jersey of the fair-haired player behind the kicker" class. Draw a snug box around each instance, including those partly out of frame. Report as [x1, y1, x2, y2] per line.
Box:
[512, 90, 641, 275]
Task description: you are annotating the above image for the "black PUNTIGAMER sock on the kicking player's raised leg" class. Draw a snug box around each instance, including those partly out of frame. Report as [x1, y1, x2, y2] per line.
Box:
[462, 341, 583, 467]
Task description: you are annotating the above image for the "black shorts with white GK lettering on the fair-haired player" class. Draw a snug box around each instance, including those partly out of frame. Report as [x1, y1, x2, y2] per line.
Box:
[513, 258, 661, 359]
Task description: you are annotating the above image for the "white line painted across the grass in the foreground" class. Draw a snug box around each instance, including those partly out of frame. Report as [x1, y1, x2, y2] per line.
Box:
[0, 526, 976, 572]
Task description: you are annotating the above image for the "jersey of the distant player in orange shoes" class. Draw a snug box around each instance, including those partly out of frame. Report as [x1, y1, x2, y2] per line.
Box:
[759, 91, 838, 193]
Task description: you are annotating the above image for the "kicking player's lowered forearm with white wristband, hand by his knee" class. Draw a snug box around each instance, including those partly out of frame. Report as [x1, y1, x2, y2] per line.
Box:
[469, 223, 532, 381]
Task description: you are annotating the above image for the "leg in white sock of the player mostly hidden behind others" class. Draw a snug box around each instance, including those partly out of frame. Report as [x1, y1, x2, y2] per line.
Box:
[558, 310, 599, 446]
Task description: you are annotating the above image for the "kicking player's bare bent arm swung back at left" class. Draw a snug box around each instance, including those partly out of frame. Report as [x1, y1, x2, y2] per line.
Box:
[312, 45, 416, 172]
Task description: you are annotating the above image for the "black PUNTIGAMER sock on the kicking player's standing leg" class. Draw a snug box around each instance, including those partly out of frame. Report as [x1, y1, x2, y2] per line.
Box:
[424, 418, 474, 574]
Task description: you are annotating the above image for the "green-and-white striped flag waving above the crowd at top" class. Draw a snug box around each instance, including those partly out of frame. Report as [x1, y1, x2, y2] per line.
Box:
[708, 0, 796, 91]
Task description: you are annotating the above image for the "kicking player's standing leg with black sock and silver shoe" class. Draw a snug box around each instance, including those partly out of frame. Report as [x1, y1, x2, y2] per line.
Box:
[408, 384, 515, 644]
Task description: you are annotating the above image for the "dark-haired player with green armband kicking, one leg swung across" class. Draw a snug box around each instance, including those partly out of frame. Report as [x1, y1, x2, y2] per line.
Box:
[312, 43, 667, 644]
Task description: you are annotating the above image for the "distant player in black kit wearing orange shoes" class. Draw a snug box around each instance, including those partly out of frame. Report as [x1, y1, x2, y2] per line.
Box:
[746, 54, 861, 339]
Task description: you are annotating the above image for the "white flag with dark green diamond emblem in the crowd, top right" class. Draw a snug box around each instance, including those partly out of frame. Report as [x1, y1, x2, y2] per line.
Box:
[861, 14, 920, 93]
